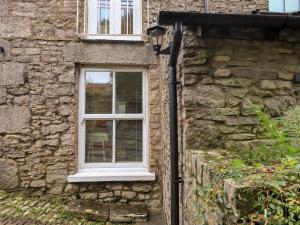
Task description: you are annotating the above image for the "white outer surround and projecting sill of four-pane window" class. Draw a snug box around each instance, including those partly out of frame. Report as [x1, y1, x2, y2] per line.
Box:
[67, 67, 155, 183]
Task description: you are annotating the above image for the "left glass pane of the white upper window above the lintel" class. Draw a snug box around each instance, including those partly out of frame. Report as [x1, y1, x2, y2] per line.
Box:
[98, 0, 110, 34]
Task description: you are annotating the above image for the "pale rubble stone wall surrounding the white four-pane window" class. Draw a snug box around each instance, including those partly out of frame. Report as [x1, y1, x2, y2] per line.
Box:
[0, 0, 162, 208]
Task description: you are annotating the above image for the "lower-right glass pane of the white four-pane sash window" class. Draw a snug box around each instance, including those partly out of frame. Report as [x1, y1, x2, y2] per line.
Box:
[116, 120, 143, 162]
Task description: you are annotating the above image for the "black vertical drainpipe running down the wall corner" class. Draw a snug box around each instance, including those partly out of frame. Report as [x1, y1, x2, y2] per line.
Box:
[169, 22, 182, 225]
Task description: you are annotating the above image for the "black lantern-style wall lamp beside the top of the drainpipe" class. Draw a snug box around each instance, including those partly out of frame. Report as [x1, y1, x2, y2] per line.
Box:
[147, 23, 170, 56]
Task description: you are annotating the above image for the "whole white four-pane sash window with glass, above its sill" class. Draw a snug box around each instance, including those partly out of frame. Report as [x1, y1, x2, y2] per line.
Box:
[79, 69, 147, 168]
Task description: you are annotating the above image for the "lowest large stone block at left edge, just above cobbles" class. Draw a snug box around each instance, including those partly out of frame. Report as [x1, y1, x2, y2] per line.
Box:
[0, 158, 18, 190]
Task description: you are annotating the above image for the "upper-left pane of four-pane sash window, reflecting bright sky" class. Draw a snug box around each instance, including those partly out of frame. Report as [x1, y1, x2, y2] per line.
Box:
[85, 72, 113, 114]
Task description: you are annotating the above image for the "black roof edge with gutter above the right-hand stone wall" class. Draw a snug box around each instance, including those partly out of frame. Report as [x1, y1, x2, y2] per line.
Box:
[158, 11, 300, 29]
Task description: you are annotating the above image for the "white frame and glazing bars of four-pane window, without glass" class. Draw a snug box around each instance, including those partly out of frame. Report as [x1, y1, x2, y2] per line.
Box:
[78, 68, 148, 172]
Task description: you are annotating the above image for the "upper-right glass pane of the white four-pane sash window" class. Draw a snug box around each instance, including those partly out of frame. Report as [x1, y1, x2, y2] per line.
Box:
[116, 72, 143, 113]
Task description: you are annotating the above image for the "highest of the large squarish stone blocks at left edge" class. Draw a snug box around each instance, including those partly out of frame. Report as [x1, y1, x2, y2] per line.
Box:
[0, 62, 24, 86]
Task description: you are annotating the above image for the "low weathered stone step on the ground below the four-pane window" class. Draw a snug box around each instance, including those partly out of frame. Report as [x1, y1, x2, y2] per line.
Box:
[66, 200, 148, 224]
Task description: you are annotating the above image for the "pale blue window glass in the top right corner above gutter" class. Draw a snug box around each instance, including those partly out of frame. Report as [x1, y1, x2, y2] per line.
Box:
[269, 0, 300, 12]
